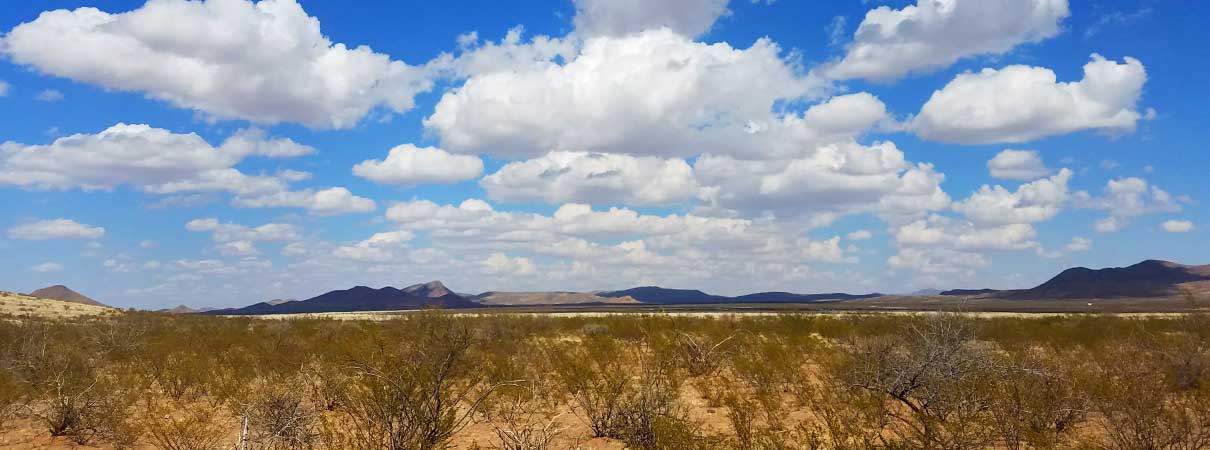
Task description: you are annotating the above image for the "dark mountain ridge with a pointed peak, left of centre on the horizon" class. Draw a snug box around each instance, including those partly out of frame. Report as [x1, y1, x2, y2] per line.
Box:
[207, 281, 479, 315]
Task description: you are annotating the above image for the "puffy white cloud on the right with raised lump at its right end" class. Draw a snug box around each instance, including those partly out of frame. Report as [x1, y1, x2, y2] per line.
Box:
[911, 54, 1147, 144]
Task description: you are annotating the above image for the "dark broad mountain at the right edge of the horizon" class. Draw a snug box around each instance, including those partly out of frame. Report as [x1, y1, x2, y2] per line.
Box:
[996, 260, 1210, 300]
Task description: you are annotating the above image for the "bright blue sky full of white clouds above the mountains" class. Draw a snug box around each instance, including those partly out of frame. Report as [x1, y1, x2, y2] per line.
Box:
[0, 0, 1210, 308]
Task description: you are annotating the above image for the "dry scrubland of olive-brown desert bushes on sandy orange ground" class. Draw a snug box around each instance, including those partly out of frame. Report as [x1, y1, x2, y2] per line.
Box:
[0, 306, 1210, 450]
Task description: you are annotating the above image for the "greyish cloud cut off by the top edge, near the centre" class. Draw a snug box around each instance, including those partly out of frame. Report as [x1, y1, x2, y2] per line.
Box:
[575, 0, 730, 38]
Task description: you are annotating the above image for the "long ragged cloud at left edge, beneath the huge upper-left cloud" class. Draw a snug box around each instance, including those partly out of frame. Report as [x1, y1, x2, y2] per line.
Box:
[0, 123, 375, 215]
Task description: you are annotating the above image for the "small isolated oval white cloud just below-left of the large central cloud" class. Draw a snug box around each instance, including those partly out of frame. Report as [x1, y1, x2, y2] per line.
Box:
[353, 144, 483, 185]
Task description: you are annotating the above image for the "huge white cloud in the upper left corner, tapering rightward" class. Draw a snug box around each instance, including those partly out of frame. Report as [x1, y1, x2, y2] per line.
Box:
[0, 0, 432, 128]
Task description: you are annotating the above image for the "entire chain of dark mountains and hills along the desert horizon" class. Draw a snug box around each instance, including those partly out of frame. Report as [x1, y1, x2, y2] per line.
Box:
[16, 260, 1190, 315]
